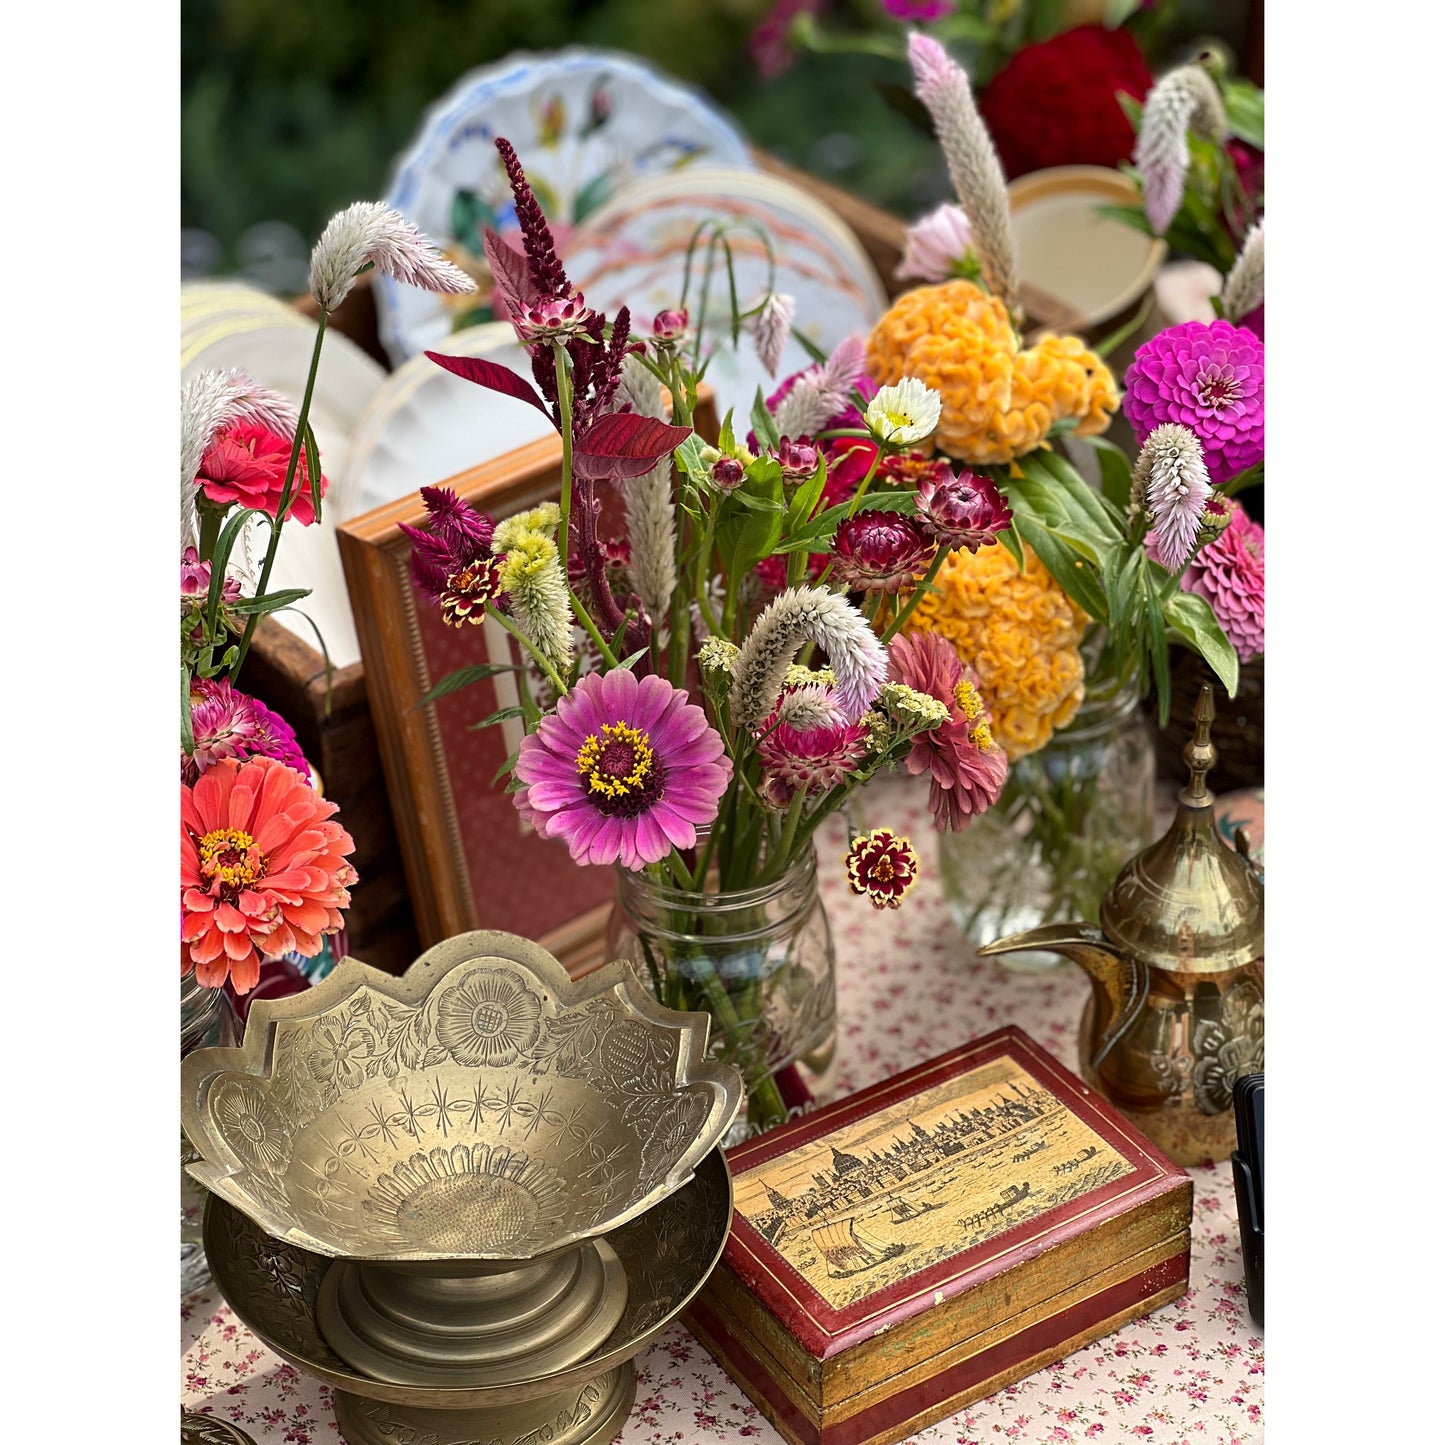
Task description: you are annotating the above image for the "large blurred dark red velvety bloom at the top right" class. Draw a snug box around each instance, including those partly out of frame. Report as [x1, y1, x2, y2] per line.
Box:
[978, 25, 1153, 176]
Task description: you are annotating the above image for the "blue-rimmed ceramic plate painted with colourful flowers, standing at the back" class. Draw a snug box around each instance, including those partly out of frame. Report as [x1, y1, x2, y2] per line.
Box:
[377, 49, 751, 364]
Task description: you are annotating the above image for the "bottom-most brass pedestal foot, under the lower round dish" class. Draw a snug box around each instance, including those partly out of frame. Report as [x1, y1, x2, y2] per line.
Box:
[331, 1360, 637, 1445]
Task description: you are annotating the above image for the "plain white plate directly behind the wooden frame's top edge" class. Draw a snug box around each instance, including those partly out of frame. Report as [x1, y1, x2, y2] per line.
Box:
[335, 321, 552, 522]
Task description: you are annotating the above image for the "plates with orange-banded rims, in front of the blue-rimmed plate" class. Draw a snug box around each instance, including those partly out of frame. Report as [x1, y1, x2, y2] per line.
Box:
[566, 166, 887, 431]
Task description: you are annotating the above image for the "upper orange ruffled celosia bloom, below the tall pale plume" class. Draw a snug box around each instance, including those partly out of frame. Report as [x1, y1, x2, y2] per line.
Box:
[867, 280, 1118, 465]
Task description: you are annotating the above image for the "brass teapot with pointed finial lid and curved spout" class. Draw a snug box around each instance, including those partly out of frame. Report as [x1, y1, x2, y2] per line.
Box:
[978, 683, 1264, 1165]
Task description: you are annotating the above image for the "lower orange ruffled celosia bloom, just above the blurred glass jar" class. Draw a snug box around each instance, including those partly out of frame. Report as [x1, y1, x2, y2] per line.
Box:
[909, 546, 1088, 762]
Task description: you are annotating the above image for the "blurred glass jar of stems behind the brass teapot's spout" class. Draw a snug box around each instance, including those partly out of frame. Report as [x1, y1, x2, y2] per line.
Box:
[938, 683, 1155, 970]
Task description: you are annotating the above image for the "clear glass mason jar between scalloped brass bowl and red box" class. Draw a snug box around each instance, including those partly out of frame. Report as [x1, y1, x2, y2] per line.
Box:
[607, 850, 838, 1144]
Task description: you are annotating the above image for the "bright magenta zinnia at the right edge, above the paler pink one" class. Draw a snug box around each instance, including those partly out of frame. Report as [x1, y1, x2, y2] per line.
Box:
[1124, 319, 1264, 487]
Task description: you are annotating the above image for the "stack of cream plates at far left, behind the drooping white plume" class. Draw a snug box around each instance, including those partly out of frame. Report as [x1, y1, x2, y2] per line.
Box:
[181, 282, 386, 668]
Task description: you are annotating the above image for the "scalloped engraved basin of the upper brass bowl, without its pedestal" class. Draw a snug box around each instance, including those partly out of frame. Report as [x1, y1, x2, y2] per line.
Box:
[182, 932, 741, 1260]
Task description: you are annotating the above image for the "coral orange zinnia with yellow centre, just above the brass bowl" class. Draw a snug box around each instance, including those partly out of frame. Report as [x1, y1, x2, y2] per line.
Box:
[181, 757, 355, 993]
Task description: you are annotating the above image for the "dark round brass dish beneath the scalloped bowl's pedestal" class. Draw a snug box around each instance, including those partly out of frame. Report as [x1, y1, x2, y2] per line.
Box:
[205, 1149, 733, 1409]
